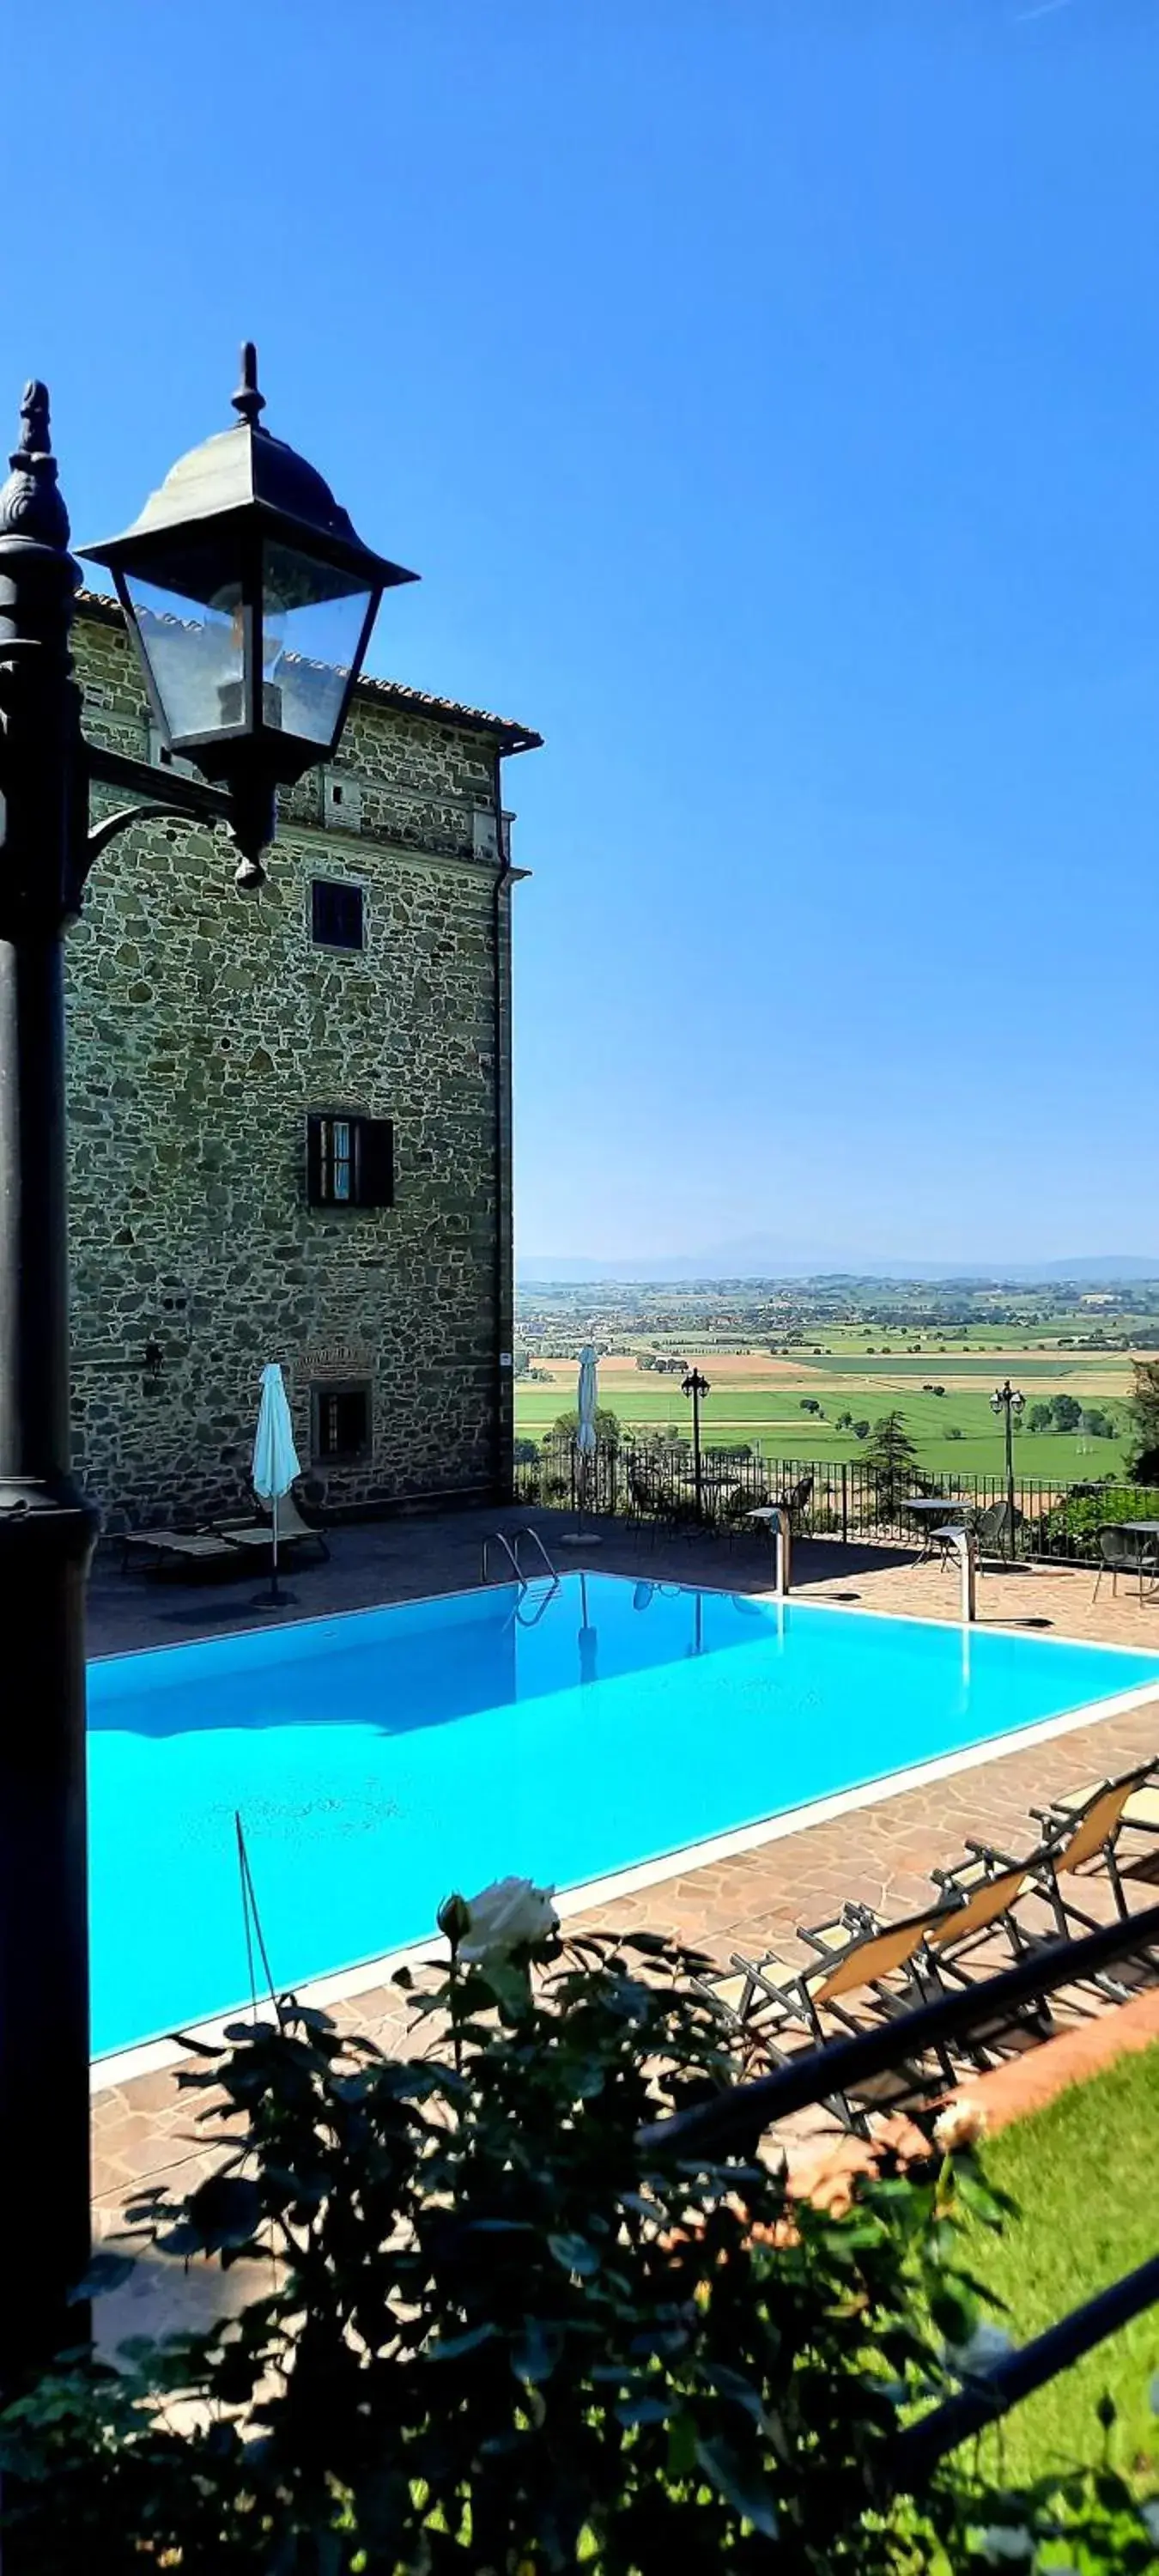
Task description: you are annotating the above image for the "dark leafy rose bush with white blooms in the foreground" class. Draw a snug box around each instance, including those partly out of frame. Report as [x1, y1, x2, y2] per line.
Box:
[0, 1883, 1159, 2576]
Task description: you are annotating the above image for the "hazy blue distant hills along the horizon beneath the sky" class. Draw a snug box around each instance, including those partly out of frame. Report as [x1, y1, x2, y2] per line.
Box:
[515, 1236, 1159, 1288]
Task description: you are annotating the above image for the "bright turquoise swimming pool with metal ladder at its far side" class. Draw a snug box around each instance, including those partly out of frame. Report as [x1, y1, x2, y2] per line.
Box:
[88, 1574, 1159, 2056]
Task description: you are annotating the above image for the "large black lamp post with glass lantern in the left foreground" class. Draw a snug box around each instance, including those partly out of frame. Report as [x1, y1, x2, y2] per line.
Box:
[0, 345, 415, 2388]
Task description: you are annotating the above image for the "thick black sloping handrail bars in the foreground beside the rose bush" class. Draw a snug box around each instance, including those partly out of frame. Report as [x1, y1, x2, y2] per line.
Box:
[636, 1906, 1159, 2496]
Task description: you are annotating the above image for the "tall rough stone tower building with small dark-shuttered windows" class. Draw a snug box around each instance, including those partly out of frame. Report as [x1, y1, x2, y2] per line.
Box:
[67, 595, 538, 1528]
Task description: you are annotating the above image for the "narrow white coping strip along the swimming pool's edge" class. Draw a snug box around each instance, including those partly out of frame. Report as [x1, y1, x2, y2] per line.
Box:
[88, 1649, 1159, 2099]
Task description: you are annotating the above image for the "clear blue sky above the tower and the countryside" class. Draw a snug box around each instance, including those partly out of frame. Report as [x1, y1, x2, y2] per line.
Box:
[0, 0, 1159, 1260]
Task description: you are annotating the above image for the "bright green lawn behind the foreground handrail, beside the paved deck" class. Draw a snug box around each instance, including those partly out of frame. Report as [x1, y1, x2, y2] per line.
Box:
[974, 2048, 1159, 2483]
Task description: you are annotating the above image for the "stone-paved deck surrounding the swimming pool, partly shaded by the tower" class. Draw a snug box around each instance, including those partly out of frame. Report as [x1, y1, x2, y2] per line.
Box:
[90, 1510, 1159, 2236]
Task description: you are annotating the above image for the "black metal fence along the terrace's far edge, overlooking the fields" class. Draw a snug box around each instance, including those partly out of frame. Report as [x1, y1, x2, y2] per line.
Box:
[515, 1432, 1159, 1566]
